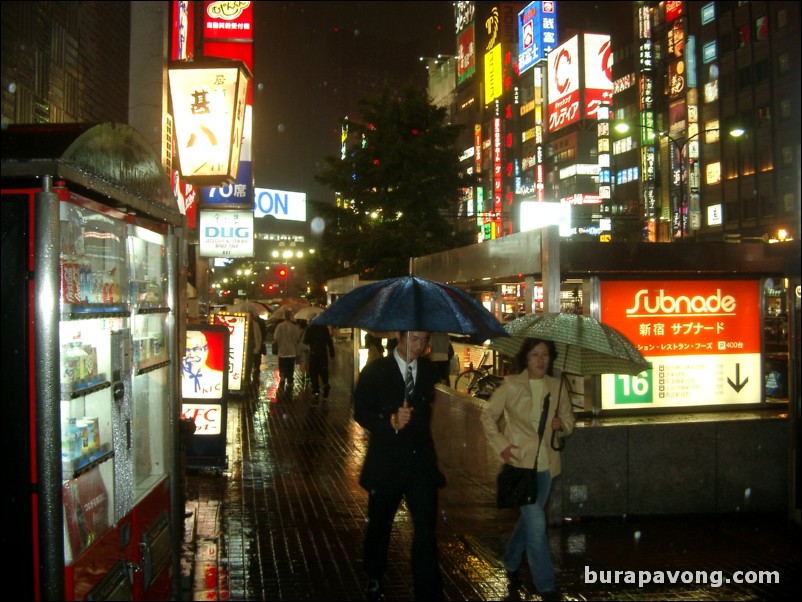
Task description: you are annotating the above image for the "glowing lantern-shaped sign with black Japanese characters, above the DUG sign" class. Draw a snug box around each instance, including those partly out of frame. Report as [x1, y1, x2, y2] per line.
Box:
[169, 59, 251, 186]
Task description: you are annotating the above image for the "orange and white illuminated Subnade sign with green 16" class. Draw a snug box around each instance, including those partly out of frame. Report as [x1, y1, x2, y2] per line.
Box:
[600, 280, 761, 410]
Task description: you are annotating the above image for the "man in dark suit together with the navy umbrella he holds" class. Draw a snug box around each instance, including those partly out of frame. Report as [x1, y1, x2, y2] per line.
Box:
[315, 275, 507, 600]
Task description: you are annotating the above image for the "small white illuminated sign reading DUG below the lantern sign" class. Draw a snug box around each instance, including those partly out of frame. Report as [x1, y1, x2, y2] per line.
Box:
[198, 210, 253, 257]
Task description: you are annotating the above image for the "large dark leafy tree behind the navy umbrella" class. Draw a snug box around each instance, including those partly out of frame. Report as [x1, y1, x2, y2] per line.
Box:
[309, 86, 475, 282]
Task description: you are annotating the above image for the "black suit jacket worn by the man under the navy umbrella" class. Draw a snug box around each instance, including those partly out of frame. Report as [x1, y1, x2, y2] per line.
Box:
[354, 354, 445, 493]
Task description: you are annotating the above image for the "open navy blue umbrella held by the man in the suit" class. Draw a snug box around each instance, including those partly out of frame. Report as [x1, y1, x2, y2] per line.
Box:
[312, 276, 507, 342]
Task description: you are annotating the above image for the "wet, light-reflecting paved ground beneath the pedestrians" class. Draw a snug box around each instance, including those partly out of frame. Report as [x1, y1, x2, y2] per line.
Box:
[181, 355, 802, 600]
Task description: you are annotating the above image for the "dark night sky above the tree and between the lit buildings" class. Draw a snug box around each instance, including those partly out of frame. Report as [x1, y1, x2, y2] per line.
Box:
[253, 1, 608, 201]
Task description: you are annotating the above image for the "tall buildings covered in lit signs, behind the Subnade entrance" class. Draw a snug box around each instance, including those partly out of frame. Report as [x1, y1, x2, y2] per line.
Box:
[437, 2, 801, 242]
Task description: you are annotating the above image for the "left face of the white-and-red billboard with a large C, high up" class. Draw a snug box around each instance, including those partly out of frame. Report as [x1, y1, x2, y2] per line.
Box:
[547, 36, 581, 132]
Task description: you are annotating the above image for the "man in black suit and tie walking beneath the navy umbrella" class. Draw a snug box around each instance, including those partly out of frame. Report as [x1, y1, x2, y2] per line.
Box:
[354, 331, 445, 600]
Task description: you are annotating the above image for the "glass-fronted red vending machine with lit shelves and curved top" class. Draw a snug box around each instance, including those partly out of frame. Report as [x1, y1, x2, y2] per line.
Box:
[1, 124, 185, 600]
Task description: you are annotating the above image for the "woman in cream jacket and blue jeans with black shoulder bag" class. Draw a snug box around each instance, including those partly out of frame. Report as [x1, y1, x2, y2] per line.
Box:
[481, 338, 575, 600]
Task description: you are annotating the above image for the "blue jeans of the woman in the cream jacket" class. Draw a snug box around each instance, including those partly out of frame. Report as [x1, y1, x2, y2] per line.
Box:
[504, 470, 557, 593]
